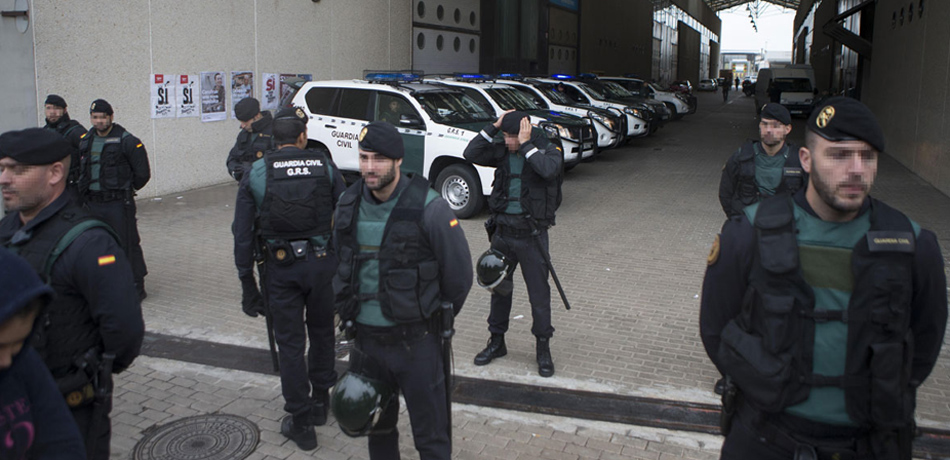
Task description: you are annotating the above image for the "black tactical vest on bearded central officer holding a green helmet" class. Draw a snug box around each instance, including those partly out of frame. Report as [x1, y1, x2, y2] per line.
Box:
[334, 174, 440, 323]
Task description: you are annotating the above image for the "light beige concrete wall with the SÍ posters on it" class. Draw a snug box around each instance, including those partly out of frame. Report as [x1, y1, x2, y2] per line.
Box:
[31, 0, 412, 197]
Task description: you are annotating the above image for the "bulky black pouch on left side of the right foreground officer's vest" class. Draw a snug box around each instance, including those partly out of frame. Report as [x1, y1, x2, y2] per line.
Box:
[719, 320, 807, 412]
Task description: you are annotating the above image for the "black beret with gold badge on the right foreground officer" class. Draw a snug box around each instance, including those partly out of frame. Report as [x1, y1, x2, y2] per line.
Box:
[806, 96, 884, 152]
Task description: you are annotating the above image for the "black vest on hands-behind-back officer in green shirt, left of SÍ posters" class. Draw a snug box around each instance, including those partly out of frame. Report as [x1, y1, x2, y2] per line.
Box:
[79, 124, 132, 192]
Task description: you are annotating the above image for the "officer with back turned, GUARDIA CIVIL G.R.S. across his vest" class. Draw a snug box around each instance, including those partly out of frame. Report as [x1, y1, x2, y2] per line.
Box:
[232, 107, 346, 450]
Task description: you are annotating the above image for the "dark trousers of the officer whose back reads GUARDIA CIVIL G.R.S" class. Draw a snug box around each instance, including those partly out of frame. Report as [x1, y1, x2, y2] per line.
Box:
[264, 252, 337, 415]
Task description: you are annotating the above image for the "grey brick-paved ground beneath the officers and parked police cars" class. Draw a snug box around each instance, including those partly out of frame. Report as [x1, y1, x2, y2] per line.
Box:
[113, 92, 950, 459]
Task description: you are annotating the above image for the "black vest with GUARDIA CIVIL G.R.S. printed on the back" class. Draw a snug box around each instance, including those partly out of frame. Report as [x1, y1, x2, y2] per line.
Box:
[260, 147, 333, 240]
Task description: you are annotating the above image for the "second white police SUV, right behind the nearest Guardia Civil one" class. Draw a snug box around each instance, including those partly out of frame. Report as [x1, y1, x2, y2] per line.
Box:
[426, 74, 597, 169]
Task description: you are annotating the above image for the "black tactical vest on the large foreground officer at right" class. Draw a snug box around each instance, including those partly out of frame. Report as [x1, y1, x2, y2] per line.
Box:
[718, 196, 916, 428]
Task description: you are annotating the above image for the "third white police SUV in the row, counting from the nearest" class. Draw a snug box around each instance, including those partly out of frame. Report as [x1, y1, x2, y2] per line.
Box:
[498, 74, 627, 149]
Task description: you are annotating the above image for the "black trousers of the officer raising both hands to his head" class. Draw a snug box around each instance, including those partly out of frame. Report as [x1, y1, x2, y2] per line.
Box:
[488, 229, 554, 337]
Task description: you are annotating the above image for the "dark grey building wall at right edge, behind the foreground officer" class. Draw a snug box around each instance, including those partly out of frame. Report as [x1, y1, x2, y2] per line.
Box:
[862, 0, 950, 194]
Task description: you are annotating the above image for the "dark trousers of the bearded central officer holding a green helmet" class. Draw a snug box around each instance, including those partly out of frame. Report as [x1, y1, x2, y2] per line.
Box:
[357, 328, 452, 460]
